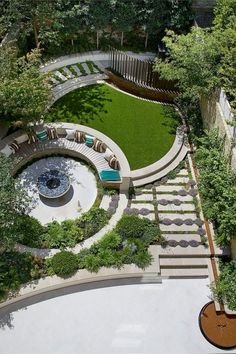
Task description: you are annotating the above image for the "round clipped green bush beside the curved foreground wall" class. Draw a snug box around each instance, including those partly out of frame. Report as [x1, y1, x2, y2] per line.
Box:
[51, 251, 78, 277]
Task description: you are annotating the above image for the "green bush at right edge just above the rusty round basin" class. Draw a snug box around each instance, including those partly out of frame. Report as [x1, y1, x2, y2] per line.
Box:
[211, 260, 236, 311]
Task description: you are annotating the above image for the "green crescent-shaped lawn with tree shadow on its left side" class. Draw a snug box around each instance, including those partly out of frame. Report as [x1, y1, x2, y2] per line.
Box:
[46, 84, 179, 170]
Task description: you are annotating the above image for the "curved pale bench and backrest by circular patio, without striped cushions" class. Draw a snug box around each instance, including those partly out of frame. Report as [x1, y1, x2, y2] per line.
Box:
[0, 123, 130, 191]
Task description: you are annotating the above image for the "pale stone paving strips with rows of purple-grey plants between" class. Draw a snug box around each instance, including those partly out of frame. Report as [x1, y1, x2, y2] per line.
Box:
[125, 160, 206, 247]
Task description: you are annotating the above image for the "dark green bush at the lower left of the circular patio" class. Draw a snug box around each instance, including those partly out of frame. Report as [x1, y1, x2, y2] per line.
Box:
[15, 215, 46, 247]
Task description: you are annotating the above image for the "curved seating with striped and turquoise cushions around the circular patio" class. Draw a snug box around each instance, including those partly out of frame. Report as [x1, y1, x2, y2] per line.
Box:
[0, 123, 130, 191]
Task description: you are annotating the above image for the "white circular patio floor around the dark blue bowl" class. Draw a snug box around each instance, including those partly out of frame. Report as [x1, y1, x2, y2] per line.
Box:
[19, 156, 97, 224]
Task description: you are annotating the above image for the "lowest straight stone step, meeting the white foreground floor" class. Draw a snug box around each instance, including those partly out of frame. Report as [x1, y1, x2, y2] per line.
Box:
[161, 268, 209, 278]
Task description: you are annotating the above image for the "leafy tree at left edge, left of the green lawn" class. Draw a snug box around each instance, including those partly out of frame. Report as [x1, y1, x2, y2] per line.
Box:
[0, 46, 50, 124]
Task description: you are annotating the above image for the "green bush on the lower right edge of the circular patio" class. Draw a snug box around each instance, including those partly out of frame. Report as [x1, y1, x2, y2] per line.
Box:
[76, 208, 109, 238]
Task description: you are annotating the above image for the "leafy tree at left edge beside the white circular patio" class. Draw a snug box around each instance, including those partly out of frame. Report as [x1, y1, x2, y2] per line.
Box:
[0, 154, 29, 250]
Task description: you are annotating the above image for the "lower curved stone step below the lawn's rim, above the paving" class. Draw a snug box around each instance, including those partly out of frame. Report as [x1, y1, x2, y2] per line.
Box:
[133, 145, 188, 187]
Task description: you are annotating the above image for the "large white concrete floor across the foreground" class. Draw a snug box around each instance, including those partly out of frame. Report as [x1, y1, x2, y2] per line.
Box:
[0, 279, 236, 354]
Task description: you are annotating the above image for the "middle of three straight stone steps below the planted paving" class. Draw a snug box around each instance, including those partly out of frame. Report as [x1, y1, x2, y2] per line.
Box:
[160, 257, 208, 268]
